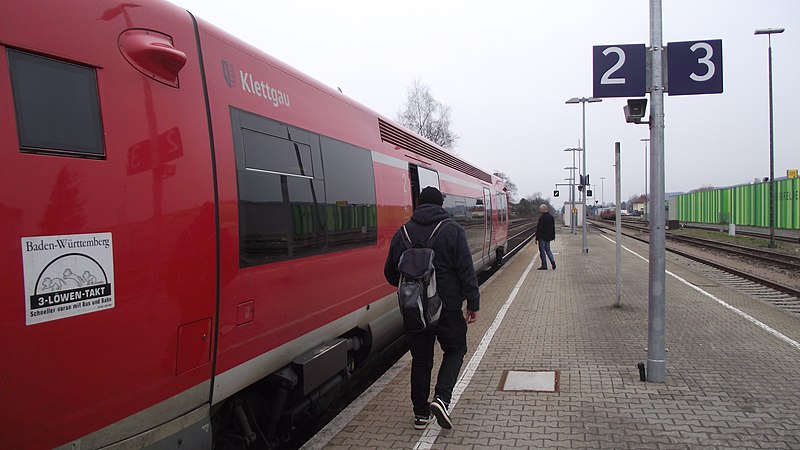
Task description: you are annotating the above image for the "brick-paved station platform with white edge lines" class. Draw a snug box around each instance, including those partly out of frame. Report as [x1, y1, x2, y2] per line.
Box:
[305, 228, 800, 449]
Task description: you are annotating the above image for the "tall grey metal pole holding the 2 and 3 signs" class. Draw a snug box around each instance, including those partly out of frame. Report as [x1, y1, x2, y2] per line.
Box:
[647, 0, 666, 383]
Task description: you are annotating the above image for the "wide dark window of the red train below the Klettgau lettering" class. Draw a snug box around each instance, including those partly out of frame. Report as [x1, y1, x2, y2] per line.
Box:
[231, 108, 377, 267]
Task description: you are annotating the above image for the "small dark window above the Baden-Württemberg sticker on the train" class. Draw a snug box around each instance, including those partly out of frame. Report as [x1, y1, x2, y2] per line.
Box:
[8, 49, 105, 158]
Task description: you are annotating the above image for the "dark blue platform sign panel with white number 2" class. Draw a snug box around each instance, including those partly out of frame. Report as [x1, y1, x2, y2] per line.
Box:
[592, 44, 647, 97]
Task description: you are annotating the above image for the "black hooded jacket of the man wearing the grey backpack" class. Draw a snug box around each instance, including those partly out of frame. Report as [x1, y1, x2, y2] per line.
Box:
[383, 204, 481, 311]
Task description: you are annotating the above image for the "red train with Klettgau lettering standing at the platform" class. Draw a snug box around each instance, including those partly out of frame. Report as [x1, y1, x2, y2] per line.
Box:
[0, 0, 508, 450]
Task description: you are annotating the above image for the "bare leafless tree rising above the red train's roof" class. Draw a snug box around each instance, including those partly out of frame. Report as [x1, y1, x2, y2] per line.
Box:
[397, 79, 459, 150]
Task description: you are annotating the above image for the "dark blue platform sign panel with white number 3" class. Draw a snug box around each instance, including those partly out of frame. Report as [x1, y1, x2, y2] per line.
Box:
[667, 39, 722, 95]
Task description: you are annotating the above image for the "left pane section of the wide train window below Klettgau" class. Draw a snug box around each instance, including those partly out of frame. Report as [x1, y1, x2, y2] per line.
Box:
[233, 110, 325, 267]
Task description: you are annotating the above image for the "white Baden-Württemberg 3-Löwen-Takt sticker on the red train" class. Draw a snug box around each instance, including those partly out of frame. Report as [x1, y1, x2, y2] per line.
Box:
[22, 233, 114, 325]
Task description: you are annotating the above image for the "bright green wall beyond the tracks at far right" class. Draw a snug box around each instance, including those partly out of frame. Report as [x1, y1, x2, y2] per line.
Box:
[670, 178, 800, 230]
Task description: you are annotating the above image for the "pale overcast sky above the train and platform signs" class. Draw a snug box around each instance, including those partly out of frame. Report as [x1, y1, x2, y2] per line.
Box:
[167, 0, 800, 206]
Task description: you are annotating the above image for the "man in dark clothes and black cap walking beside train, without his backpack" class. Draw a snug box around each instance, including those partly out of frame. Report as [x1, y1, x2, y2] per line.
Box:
[383, 186, 480, 430]
